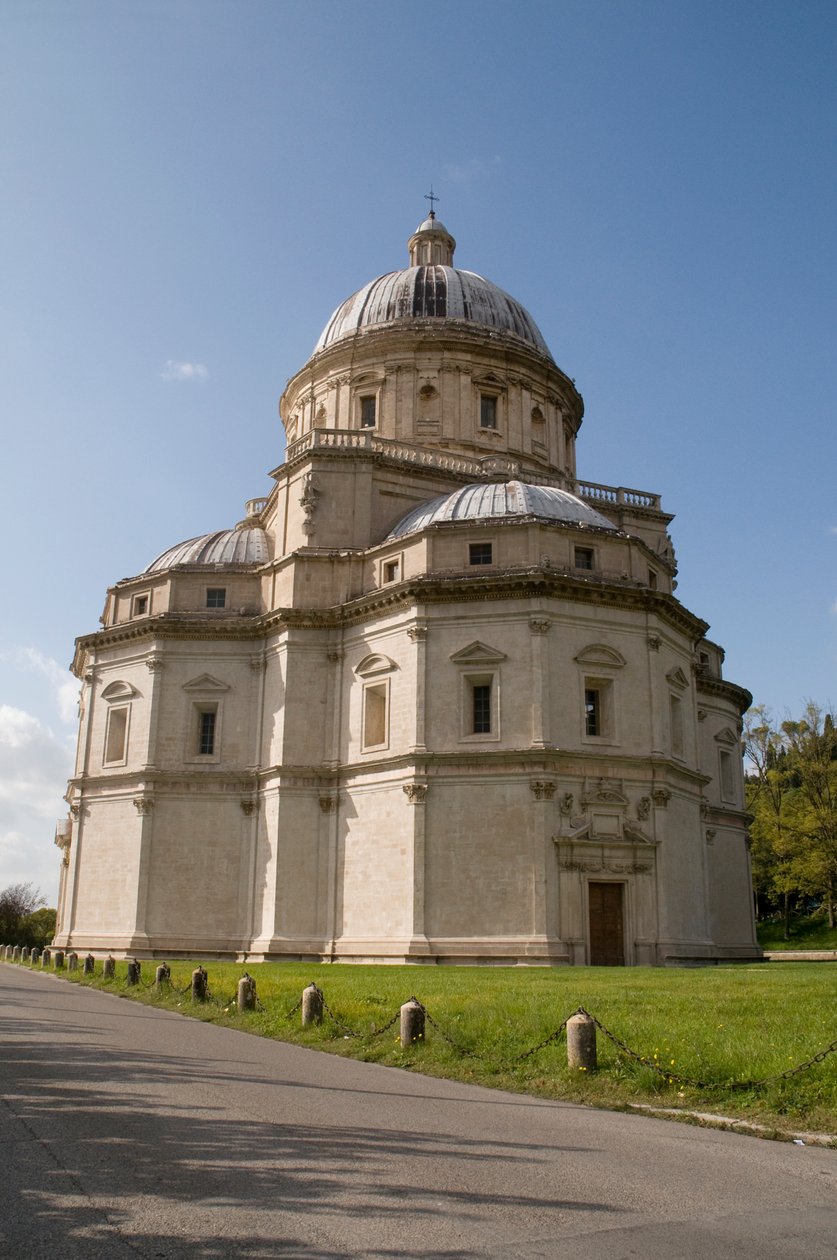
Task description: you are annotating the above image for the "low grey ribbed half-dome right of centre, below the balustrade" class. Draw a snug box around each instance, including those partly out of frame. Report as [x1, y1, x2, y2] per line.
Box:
[387, 481, 616, 539]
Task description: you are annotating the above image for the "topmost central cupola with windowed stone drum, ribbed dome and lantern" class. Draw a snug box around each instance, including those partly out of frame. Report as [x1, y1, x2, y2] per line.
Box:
[279, 212, 584, 485]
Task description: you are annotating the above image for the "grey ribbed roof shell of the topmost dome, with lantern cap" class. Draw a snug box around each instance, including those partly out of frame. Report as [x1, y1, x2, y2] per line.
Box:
[314, 265, 552, 359]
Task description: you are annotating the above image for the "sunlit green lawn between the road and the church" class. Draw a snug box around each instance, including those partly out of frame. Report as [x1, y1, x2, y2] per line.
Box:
[8, 961, 837, 1134]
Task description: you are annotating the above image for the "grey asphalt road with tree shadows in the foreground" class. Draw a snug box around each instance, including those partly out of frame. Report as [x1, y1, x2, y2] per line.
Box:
[0, 965, 837, 1260]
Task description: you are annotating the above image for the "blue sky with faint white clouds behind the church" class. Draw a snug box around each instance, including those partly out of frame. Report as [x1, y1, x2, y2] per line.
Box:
[0, 0, 837, 897]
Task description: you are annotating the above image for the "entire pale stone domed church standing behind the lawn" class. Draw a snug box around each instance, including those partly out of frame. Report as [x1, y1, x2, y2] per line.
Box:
[55, 213, 760, 965]
